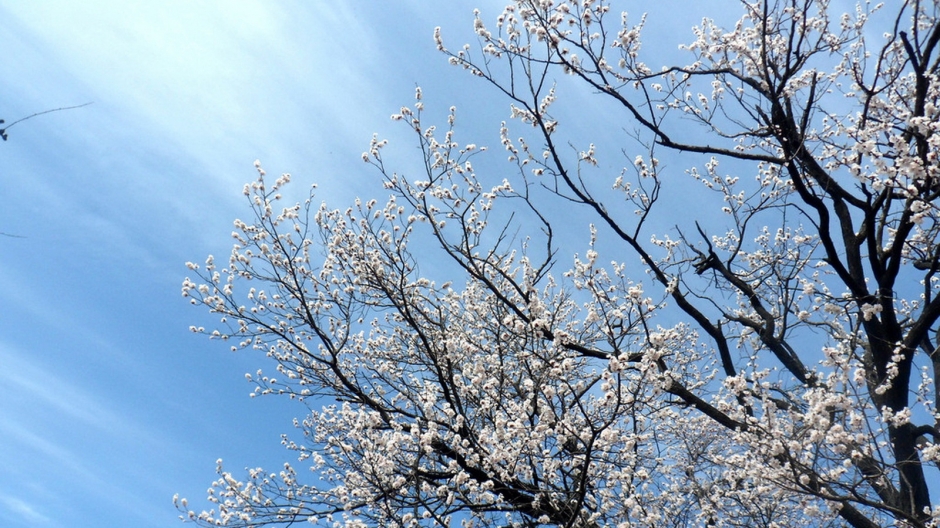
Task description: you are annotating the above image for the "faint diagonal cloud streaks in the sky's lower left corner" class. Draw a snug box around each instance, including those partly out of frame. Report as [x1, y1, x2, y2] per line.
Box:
[0, 342, 181, 526]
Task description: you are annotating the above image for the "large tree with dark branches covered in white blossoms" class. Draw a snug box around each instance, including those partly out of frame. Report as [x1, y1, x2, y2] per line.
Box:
[178, 0, 940, 527]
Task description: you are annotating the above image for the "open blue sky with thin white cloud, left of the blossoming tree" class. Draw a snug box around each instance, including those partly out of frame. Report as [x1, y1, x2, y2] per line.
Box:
[0, 0, 720, 528]
